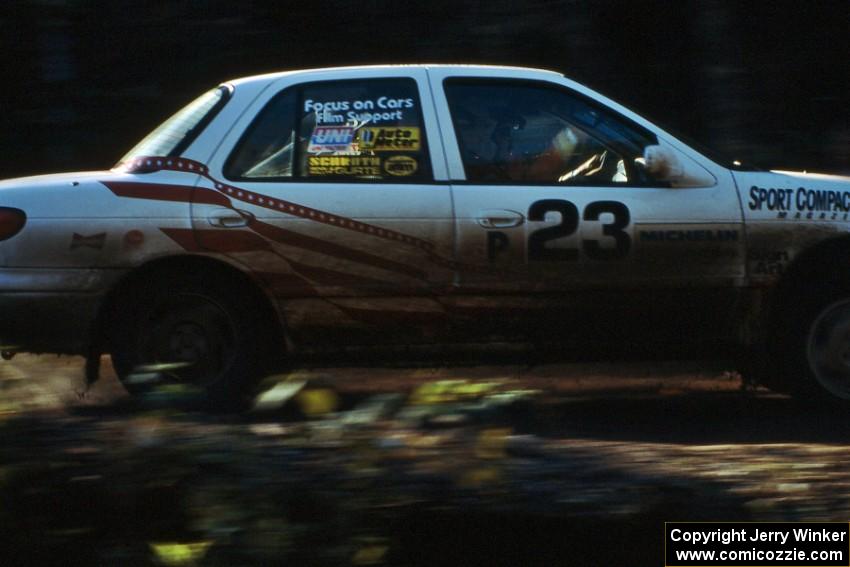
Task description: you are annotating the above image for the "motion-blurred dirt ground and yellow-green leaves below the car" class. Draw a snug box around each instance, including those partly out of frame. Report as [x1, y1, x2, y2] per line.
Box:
[0, 356, 850, 567]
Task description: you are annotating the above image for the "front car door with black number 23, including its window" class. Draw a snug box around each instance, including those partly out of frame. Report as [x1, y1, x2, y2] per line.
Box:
[430, 68, 745, 348]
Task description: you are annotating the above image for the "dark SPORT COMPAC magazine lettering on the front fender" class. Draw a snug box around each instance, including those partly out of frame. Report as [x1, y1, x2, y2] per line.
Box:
[747, 185, 850, 221]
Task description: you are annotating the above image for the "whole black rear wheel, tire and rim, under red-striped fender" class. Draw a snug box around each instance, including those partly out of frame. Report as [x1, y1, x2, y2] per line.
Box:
[111, 274, 271, 410]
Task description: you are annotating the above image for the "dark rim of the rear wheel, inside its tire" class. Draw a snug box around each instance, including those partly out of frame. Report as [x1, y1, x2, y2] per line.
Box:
[137, 293, 236, 387]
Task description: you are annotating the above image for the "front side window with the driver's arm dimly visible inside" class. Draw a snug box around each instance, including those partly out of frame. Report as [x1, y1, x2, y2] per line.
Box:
[445, 79, 657, 185]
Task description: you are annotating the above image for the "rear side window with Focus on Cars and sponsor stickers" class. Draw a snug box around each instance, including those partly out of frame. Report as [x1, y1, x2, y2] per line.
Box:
[225, 79, 431, 182]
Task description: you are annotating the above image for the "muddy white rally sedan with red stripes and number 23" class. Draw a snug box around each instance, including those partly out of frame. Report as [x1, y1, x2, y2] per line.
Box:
[0, 65, 850, 403]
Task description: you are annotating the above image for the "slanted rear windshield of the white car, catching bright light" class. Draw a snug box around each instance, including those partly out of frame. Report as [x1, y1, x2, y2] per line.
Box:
[118, 86, 231, 165]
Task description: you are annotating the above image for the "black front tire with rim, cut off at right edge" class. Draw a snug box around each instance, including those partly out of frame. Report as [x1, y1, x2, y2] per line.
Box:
[768, 284, 850, 408]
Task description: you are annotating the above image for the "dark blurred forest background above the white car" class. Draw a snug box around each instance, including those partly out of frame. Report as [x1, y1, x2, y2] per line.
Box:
[0, 0, 850, 177]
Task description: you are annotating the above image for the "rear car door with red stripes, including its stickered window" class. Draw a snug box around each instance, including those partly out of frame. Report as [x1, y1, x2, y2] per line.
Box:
[192, 68, 454, 345]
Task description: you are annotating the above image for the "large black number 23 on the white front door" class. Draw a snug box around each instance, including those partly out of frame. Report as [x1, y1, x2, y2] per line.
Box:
[528, 199, 632, 262]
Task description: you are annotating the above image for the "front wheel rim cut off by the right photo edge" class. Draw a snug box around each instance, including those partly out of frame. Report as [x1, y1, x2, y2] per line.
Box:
[807, 299, 850, 399]
